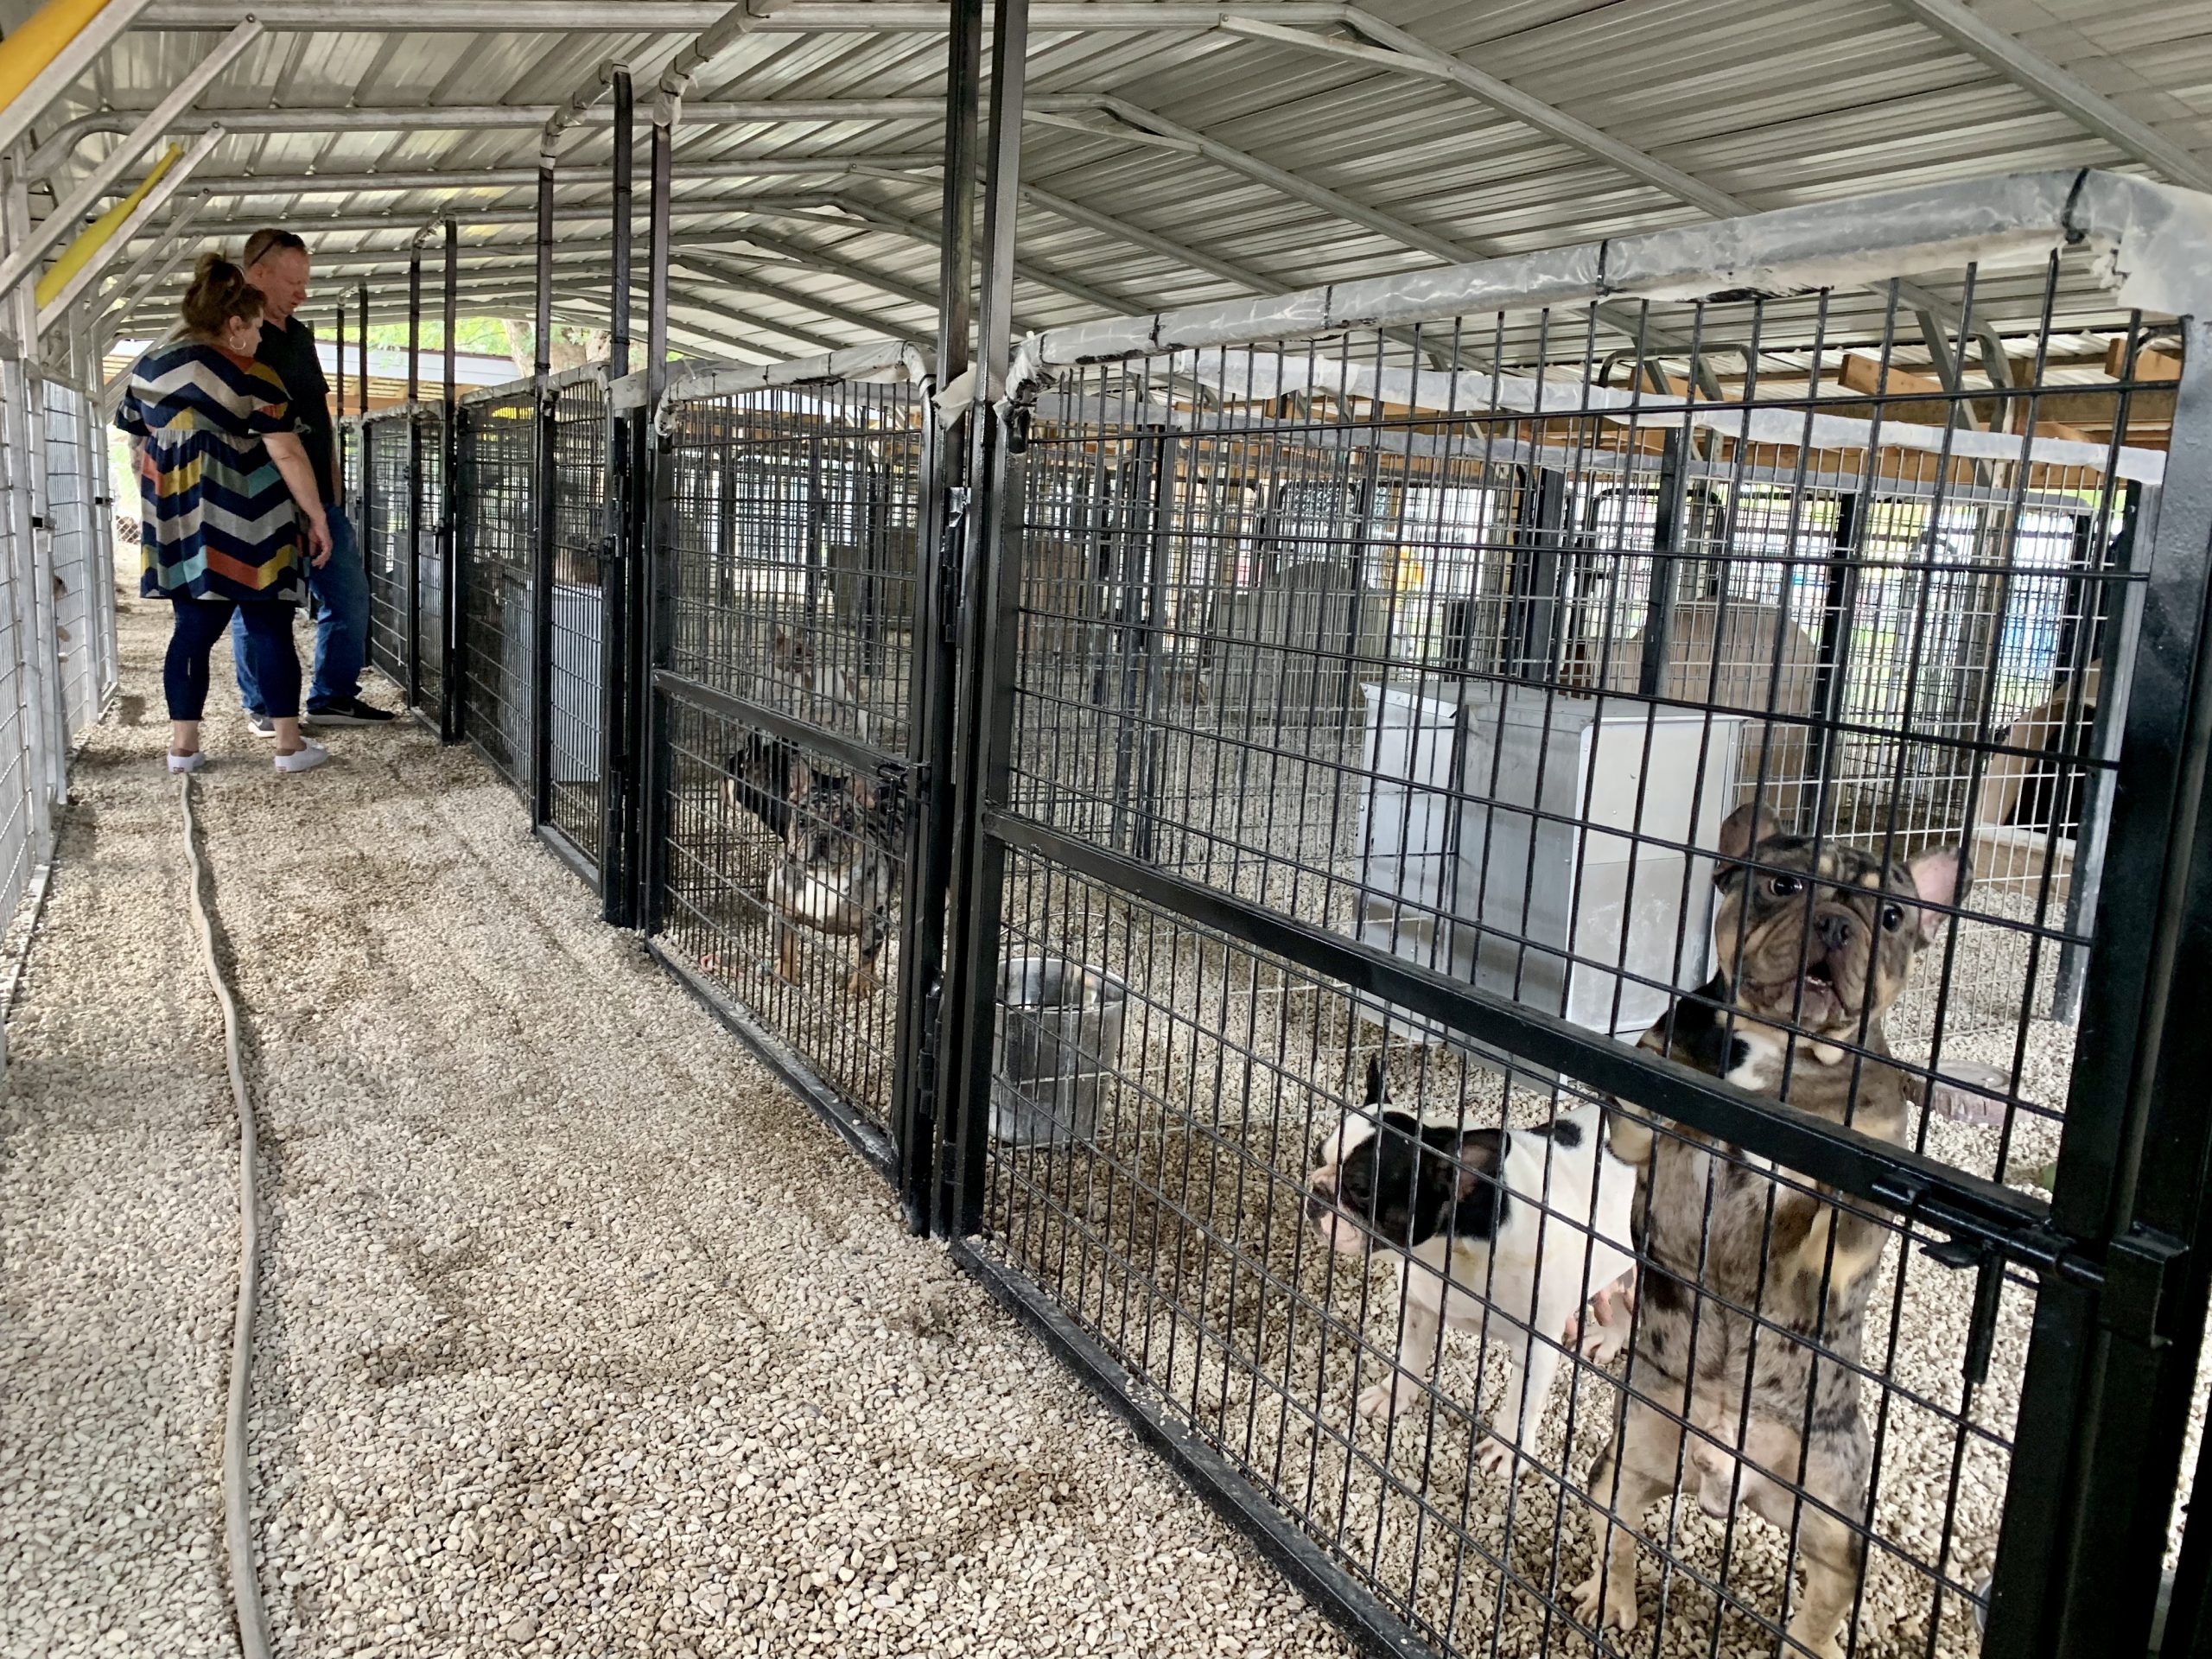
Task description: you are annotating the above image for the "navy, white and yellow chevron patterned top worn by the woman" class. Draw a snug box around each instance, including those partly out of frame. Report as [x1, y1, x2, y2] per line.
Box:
[115, 340, 303, 604]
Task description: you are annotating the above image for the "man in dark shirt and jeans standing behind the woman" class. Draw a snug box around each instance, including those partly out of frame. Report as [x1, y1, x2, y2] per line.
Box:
[230, 230, 391, 736]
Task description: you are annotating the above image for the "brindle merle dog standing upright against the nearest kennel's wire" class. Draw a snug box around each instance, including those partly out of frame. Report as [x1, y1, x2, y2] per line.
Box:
[1575, 807, 1968, 1659]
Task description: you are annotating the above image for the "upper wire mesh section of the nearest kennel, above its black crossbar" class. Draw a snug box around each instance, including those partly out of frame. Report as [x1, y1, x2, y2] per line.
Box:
[1008, 301, 2164, 1179]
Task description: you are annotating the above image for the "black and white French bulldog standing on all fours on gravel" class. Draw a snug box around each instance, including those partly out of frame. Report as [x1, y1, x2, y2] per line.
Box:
[1305, 1059, 1637, 1473]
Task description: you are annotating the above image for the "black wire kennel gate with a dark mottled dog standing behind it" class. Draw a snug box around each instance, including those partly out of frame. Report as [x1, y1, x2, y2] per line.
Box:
[644, 345, 943, 1211]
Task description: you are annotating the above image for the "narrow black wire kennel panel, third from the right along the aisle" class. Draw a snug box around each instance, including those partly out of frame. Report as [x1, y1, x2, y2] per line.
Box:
[546, 365, 611, 862]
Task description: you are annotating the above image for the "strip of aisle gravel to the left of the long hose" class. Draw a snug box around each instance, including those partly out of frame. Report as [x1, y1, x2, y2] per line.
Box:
[0, 626, 237, 1659]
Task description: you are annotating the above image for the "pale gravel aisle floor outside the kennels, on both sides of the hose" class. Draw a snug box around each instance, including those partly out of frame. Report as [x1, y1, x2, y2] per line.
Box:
[0, 606, 1344, 1655]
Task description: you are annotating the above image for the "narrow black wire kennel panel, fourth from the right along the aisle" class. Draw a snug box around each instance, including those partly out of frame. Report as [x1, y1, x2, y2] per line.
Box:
[455, 387, 537, 790]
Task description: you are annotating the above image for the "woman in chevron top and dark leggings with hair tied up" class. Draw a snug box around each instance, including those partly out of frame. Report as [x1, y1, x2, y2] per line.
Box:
[115, 254, 329, 772]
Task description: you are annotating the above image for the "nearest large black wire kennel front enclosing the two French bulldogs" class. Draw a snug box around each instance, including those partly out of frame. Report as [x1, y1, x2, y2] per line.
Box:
[940, 173, 2212, 1655]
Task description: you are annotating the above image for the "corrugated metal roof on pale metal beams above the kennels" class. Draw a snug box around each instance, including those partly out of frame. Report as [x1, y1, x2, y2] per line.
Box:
[13, 0, 2212, 359]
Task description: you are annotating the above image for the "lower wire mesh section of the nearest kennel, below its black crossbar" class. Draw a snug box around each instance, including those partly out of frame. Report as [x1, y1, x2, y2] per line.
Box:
[982, 852, 2033, 1656]
